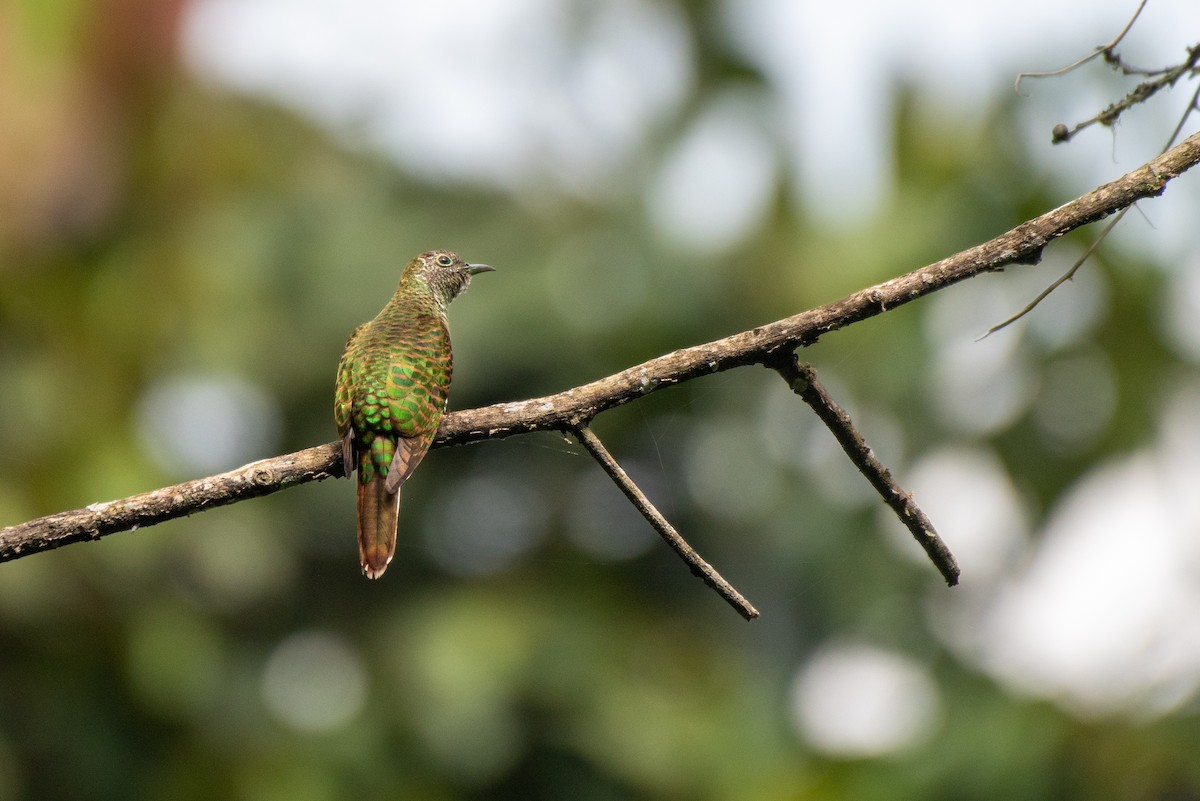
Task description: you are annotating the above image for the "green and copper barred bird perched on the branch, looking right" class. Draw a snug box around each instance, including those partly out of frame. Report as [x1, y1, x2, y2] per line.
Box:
[334, 251, 496, 579]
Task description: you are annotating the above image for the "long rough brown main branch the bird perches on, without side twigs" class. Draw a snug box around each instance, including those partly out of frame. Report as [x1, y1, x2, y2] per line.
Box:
[0, 134, 1200, 561]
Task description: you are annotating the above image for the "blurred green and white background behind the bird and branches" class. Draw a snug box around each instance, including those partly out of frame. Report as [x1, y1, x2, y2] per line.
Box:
[0, 0, 1200, 801]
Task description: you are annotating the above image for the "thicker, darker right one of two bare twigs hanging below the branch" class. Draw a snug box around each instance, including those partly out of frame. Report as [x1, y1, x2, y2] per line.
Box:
[768, 354, 959, 586]
